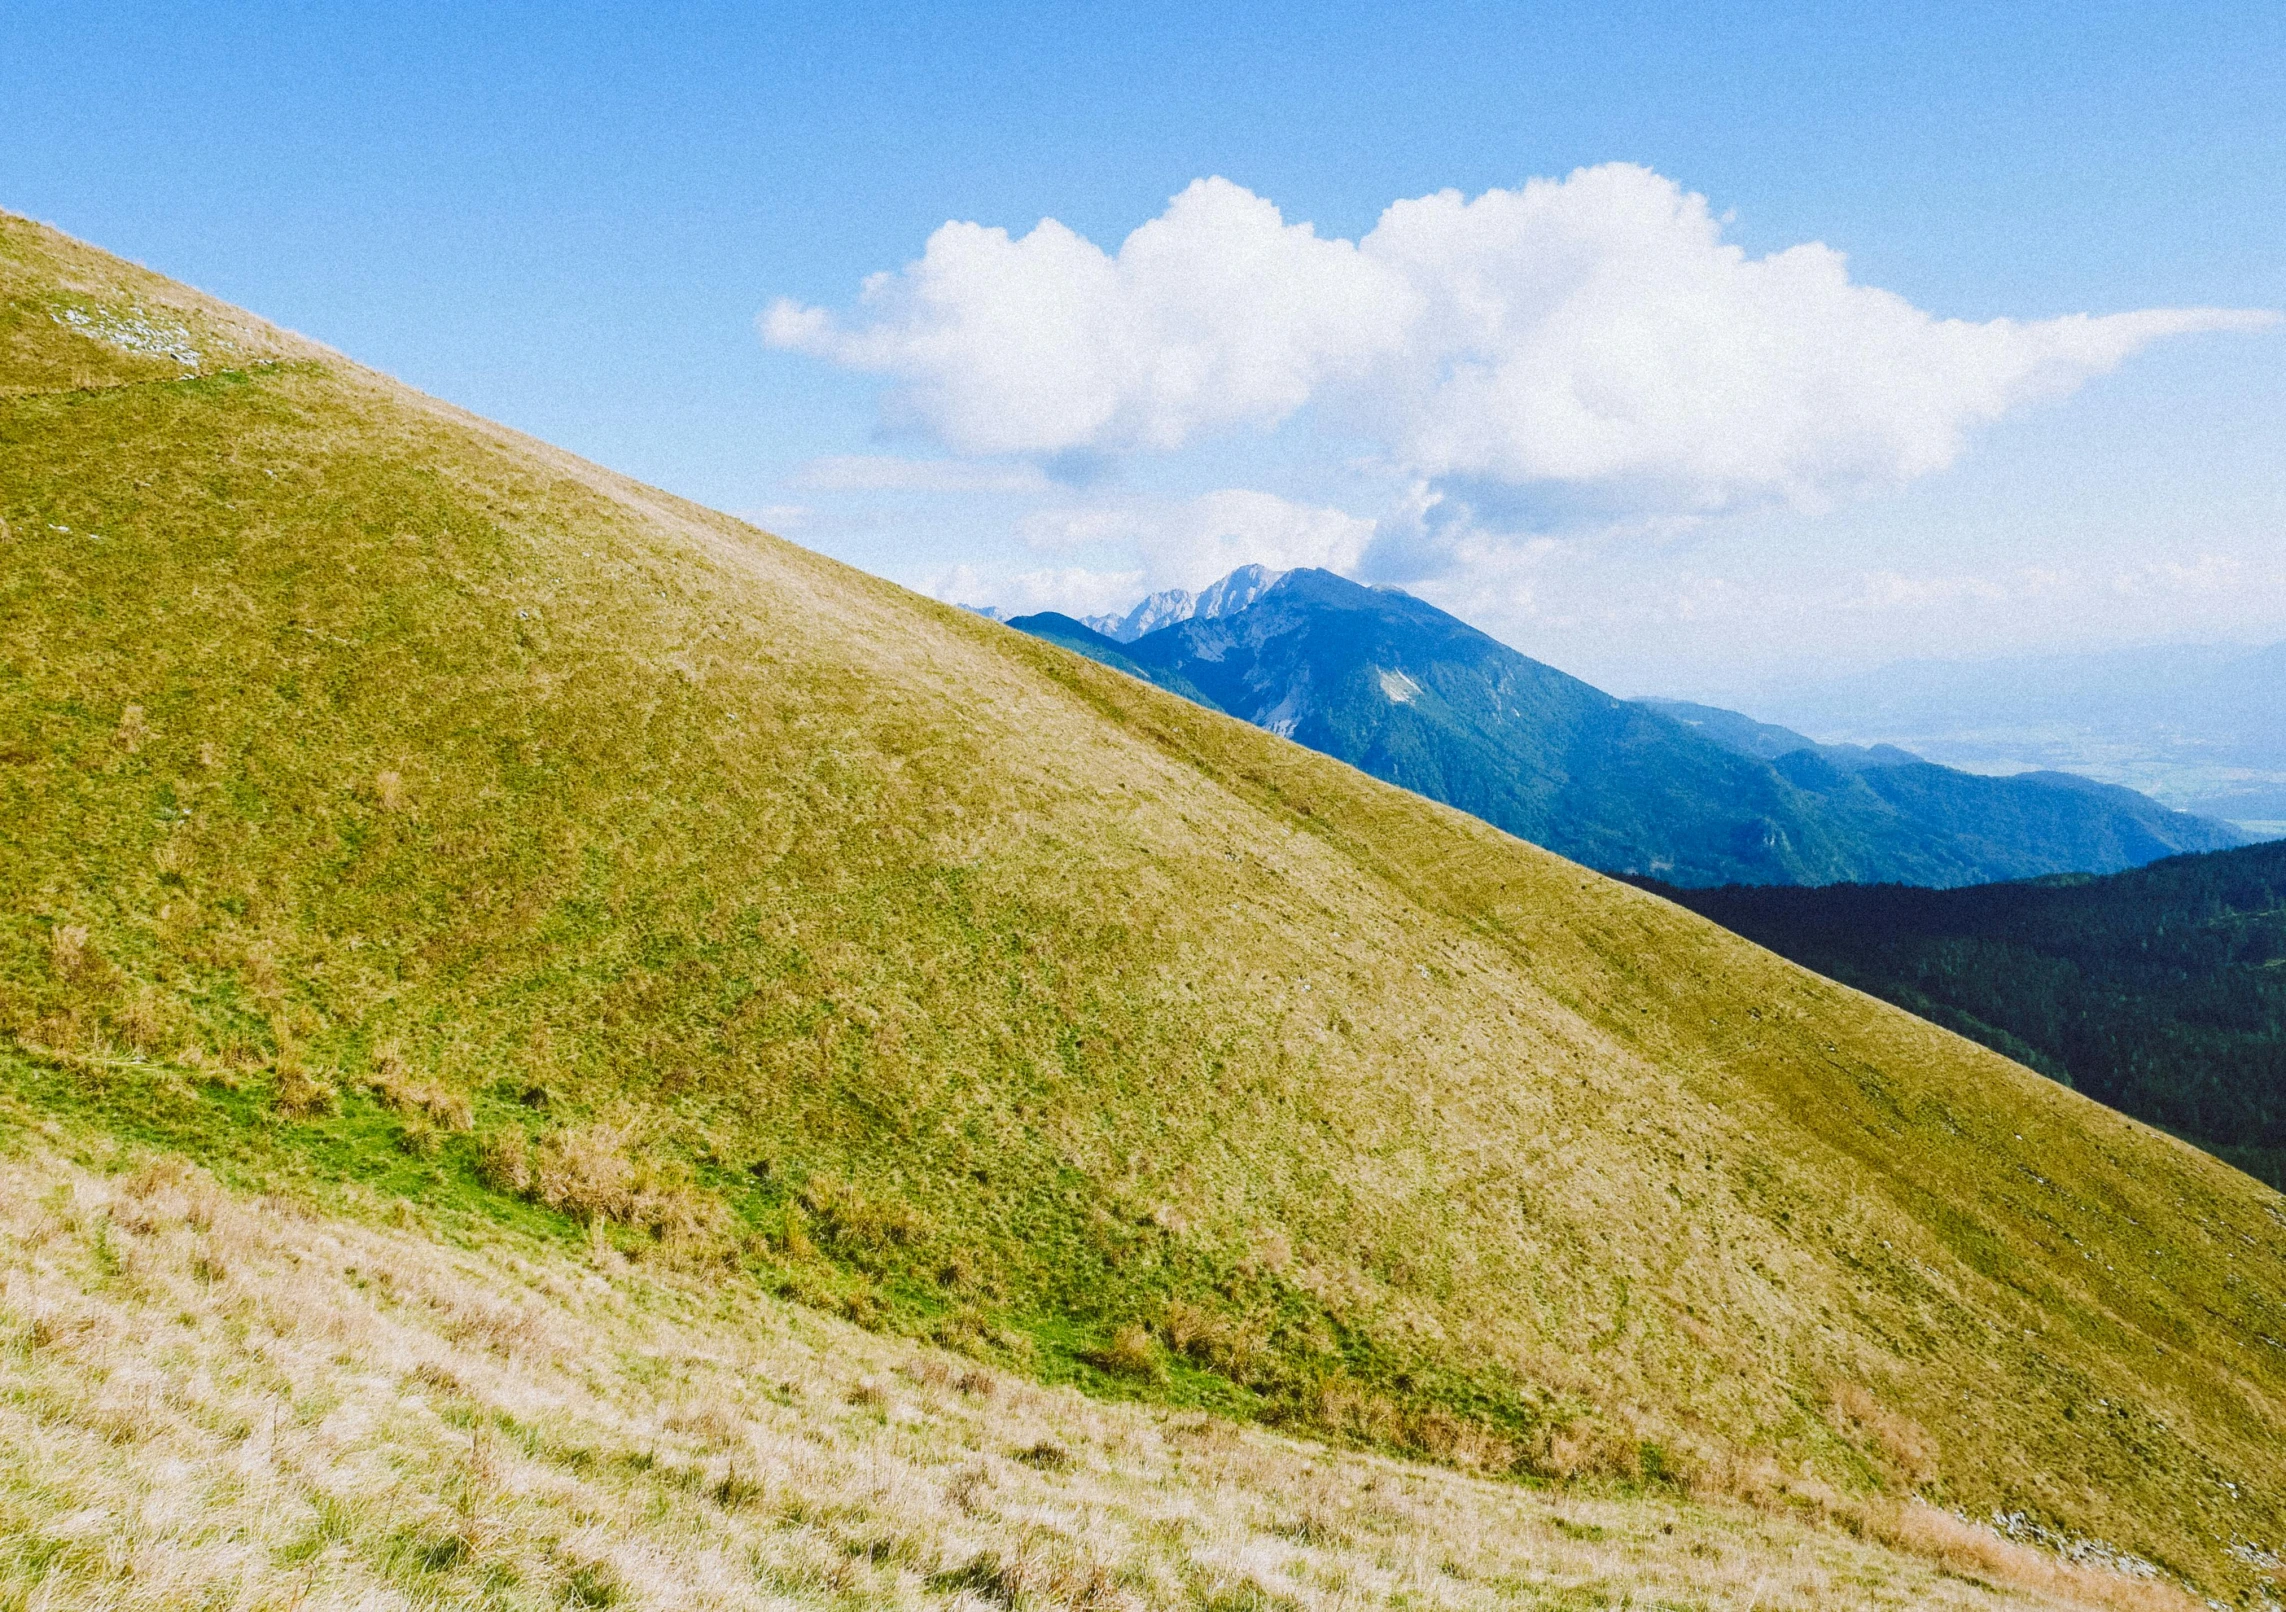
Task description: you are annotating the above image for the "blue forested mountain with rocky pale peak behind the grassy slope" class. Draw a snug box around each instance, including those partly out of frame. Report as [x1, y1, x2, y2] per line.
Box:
[1010, 567, 2245, 885]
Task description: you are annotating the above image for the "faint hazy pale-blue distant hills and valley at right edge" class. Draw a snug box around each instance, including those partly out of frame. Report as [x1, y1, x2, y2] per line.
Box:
[1719, 643, 2286, 832]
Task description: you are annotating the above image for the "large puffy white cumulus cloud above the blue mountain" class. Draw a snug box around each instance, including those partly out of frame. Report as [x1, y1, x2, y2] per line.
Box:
[761, 165, 2277, 510]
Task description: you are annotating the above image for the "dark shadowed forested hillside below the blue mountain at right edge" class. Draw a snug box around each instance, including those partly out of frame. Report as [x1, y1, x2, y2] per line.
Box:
[1671, 844, 2286, 1187]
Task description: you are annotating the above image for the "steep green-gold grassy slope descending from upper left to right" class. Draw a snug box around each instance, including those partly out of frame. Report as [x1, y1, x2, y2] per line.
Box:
[0, 220, 2286, 1589]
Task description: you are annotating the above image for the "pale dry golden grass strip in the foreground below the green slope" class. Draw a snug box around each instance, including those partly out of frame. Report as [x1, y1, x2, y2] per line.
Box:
[0, 1143, 2188, 1612]
